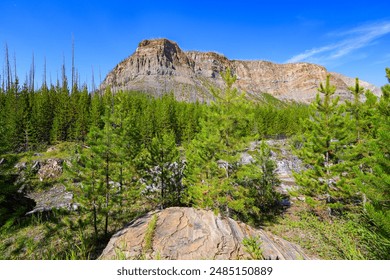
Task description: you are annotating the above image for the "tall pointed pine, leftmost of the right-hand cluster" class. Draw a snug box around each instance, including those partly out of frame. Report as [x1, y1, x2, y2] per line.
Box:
[295, 76, 346, 198]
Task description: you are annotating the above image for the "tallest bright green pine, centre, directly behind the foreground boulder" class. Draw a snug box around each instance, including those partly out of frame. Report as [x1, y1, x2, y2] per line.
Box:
[186, 69, 253, 216]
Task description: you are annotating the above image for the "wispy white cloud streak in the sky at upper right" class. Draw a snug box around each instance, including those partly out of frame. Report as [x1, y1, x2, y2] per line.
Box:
[286, 21, 390, 64]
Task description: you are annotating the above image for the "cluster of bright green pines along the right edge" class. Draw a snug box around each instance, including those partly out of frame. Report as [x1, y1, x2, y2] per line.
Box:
[290, 71, 390, 258]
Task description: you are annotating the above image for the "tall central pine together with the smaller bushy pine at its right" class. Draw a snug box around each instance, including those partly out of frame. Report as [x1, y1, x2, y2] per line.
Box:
[185, 70, 277, 222]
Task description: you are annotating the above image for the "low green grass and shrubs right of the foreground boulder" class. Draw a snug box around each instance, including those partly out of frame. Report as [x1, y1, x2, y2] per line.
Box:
[271, 211, 389, 260]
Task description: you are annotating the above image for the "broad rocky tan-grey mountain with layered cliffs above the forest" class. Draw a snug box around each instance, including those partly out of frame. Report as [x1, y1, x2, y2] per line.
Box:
[101, 39, 380, 102]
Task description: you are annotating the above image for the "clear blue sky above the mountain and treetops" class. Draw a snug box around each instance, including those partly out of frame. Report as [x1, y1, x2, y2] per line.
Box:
[0, 0, 390, 86]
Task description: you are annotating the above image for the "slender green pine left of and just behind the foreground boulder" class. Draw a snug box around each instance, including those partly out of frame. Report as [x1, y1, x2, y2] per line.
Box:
[70, 107, 120, 238]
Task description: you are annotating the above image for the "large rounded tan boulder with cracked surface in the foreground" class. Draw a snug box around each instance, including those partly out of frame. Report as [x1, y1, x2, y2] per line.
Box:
[100, 207, 309, 260]
